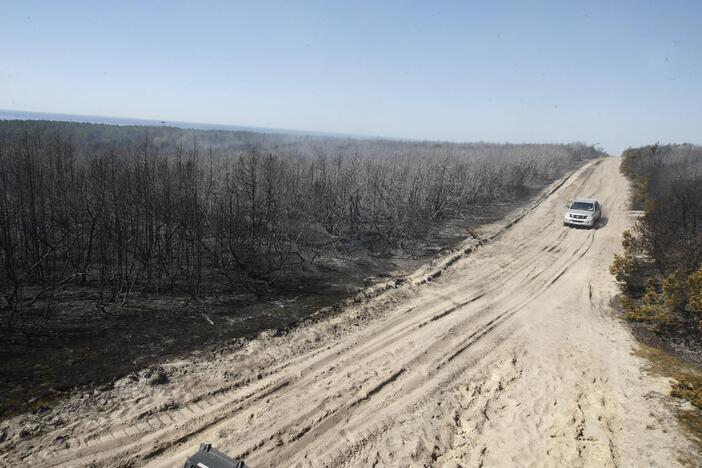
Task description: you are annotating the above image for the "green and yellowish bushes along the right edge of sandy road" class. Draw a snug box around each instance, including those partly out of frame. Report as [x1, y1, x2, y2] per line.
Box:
[610, 144, 702, 447]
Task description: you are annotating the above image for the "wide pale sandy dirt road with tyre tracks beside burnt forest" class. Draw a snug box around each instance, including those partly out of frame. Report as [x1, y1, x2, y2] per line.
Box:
[0, 158, 694, 467]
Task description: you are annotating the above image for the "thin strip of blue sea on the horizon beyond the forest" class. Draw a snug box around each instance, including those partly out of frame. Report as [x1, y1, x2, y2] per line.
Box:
[0, 109, 368, 139]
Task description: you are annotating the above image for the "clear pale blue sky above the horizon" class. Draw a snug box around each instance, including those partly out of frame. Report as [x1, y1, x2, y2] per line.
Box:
[0, 0, 702, 152]
